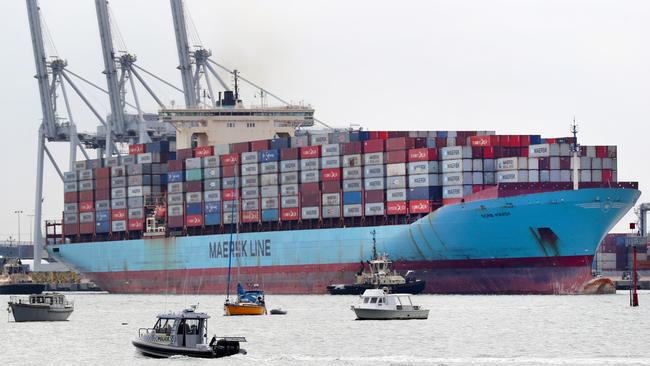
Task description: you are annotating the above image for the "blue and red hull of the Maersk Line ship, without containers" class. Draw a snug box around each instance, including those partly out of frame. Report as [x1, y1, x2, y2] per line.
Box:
[48, 188, 640, 294]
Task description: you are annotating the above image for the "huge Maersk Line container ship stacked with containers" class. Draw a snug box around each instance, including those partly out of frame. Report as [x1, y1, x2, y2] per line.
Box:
[47, 92, 640, 294]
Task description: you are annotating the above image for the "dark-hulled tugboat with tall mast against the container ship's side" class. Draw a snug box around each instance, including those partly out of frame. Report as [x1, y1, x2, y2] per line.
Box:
[327, 230, 426, 295]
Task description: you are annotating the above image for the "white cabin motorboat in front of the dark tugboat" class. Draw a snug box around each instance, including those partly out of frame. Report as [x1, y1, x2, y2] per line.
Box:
[351, 289, 429, 320]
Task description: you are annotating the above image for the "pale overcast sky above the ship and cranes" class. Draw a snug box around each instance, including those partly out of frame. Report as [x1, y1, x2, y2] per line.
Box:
[0, 0, 650, 241]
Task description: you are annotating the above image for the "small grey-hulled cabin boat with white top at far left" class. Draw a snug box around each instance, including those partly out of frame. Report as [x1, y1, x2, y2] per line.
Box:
[7, 292, 74, 322]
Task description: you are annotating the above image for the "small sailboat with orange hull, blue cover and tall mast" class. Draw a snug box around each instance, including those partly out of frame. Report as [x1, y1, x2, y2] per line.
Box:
[223, 170, 266, 316]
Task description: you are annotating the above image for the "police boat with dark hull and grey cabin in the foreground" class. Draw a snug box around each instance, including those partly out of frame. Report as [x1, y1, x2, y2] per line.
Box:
[132, 306, 246, 358]
